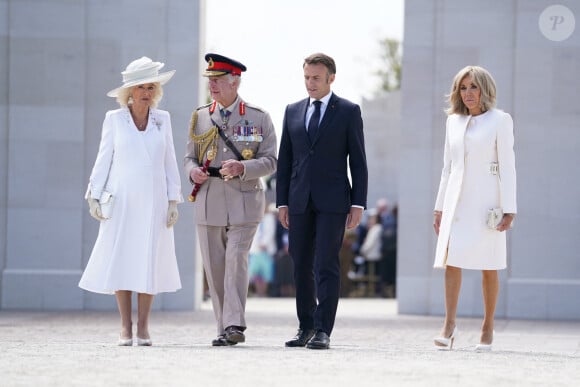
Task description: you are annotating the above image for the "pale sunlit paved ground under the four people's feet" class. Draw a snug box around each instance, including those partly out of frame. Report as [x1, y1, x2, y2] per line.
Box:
[0, 298, 580, 387]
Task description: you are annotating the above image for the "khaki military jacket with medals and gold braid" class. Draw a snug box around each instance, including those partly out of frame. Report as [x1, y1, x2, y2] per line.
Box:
[184, 97, 277, 226]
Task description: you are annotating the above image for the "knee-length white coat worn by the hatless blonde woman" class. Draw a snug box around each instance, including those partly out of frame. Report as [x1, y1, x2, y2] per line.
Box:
[434, 109, 517, 270]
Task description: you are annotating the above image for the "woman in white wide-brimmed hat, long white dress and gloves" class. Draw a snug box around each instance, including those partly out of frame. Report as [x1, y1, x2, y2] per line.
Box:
[79, 57, 183, 345]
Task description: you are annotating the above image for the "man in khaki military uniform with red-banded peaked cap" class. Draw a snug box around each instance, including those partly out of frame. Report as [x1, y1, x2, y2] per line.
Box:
[184, 54, 277, 346]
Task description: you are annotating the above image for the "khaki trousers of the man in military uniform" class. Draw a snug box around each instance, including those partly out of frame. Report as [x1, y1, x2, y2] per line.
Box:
[197, 223, 258, 336]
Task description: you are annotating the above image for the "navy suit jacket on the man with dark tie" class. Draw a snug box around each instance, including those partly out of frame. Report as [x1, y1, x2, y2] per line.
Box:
[276, 93, 368, 215]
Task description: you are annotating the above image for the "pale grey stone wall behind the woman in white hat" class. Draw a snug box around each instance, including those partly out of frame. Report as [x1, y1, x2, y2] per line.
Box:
[0, 0, 203, 309]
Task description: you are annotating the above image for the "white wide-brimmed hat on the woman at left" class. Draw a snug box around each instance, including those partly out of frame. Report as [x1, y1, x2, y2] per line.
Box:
[107, 56, 175, 97]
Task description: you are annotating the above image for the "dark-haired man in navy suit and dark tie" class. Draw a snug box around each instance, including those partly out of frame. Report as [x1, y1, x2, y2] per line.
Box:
[276, 53, 368, 349]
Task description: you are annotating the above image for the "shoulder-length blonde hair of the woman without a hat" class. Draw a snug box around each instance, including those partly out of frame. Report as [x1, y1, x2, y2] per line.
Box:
[445, 66, 496, 115]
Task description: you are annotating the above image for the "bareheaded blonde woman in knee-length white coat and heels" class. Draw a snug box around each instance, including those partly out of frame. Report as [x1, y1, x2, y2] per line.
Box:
[433, 66, 517, 350]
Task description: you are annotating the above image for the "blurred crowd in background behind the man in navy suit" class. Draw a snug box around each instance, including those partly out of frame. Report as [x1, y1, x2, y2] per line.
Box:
[242, 199, 397, 298]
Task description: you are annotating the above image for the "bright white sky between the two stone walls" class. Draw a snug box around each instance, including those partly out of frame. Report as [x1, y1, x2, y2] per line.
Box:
[205, 0, 404, 132]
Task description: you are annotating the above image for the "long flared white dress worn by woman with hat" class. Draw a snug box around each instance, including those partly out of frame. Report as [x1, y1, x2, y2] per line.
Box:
[79, 108, 183, 294]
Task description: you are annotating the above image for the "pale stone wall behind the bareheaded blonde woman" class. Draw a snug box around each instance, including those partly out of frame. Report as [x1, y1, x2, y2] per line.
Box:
[397, 0, 580, 319]
